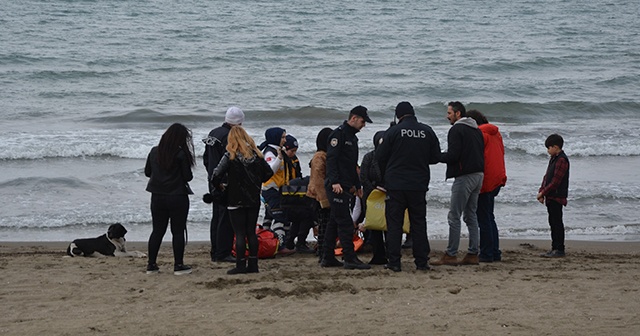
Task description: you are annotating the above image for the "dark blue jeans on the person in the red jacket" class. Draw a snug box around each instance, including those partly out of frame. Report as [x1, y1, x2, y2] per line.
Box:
[476, 187, 502, 261]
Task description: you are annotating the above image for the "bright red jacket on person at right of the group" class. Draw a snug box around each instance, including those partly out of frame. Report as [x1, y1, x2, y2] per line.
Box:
[478, 124, 507, 193]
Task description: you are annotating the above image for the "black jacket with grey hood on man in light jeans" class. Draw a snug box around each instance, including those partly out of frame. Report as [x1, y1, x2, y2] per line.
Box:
[440, 117, 484, 178]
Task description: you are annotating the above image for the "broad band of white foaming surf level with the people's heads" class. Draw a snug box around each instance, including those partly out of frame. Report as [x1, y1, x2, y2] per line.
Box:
[0, 120, 640, 160]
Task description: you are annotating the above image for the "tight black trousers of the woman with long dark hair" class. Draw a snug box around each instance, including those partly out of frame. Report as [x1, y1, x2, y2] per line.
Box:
[148, 194, 189, 265]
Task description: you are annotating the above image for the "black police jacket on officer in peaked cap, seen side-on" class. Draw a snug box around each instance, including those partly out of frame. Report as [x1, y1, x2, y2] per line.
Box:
[325, 121, 361, 191]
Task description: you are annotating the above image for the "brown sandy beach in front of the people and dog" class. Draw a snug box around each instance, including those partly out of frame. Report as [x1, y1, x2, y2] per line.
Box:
[0, 240, 640, 335]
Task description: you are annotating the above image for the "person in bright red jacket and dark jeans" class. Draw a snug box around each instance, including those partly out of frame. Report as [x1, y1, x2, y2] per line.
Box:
[467, 110, 507, 262]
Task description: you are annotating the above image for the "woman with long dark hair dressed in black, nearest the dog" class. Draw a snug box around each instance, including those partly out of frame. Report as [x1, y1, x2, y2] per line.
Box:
[144, 123, 196, 275]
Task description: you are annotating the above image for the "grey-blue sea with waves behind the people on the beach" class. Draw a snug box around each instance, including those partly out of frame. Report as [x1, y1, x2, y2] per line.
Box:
[0, 0, 640, 241]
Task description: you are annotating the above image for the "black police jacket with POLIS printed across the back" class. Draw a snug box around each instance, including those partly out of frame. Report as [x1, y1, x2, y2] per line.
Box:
[376, 116, 440, 191]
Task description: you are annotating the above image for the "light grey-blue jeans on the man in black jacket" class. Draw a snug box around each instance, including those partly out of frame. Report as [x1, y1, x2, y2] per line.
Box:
[446, 173, 484, 257]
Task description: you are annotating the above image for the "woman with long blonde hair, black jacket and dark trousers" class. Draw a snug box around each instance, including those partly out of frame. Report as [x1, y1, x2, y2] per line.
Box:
[211, 126, 273, 274]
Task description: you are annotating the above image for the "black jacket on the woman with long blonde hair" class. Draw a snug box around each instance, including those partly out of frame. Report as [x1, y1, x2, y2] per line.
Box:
[212, 153, 273, 208]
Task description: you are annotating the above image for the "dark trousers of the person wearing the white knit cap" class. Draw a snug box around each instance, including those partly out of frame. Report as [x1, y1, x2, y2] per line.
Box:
[209, 203, 233, 261]
